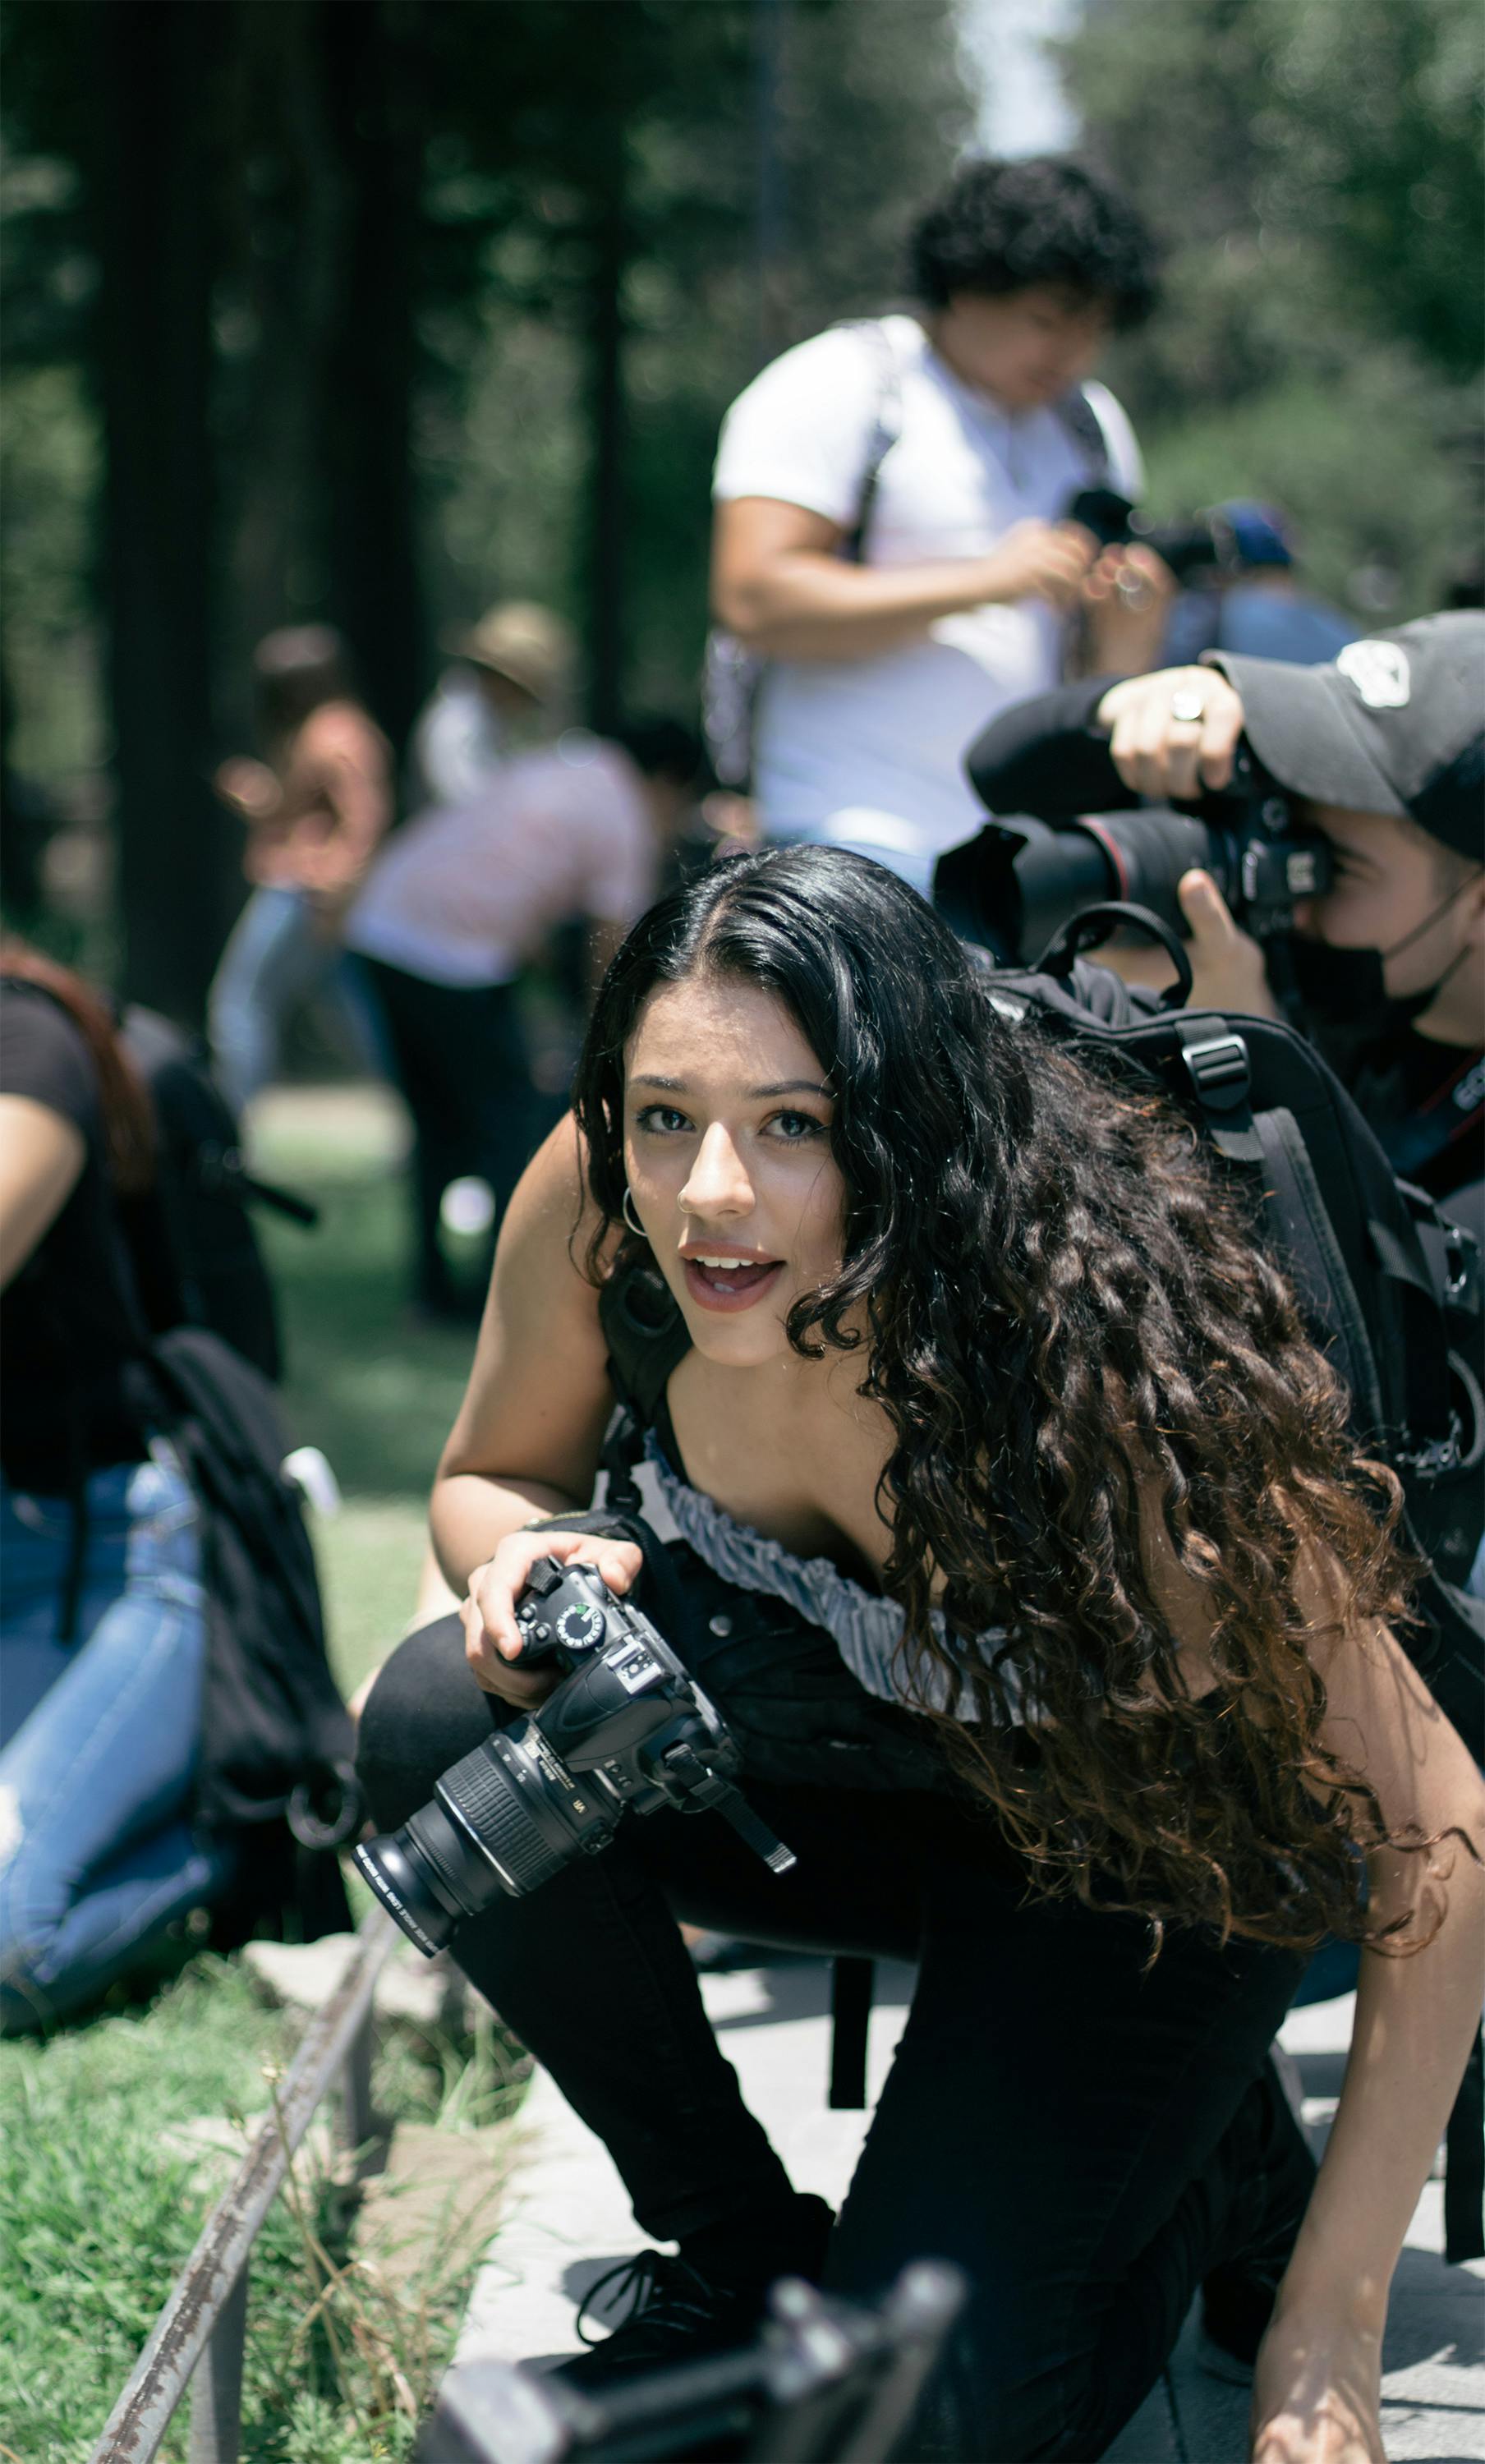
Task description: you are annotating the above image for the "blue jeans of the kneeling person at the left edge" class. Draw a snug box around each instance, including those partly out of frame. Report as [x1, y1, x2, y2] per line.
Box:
[0, 1461, 229, 2025]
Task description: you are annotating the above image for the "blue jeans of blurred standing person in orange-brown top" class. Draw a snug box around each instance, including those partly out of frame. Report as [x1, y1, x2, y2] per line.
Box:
[209, 890, 389, 1114]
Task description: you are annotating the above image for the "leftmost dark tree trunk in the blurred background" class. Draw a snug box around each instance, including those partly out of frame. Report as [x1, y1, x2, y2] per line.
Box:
[91, 0, 237, 1020]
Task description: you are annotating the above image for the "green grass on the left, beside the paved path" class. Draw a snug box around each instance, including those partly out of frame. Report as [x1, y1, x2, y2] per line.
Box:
[0, 1089, 520, 2464]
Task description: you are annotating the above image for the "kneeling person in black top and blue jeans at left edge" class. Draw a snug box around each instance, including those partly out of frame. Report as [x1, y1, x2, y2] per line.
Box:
[0, 941, 234, 2033]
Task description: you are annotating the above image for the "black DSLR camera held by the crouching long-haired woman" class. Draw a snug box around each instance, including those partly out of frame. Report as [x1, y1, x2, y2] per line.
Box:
[355, 1557, 795, 1959]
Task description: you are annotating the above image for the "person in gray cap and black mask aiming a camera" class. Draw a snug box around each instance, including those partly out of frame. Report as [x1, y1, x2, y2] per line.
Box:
[970, 609, 1485, 1237]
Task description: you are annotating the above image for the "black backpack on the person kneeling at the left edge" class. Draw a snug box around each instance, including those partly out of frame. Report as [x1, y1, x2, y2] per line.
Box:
[118, 1008, 315, 1380]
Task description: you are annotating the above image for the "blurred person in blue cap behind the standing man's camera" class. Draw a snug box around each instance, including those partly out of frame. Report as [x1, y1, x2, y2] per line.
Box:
[1157, 498, 1362, 668]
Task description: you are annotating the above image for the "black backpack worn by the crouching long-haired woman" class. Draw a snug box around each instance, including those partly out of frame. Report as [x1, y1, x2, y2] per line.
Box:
[987, 904, 1485, 1762]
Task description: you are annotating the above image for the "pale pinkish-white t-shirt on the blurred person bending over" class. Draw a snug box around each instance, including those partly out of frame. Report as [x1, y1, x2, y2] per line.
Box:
[345, 729, 658, 988]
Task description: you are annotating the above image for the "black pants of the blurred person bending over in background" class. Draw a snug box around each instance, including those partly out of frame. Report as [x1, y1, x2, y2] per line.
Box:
[365, 958, 540, 1311]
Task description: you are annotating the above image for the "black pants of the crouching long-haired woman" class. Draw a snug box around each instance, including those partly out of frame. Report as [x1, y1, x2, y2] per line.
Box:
[362, 1592, 1303, 2464]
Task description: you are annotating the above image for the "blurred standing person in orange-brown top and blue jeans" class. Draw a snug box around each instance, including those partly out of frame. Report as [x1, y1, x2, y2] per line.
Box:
[207, 623, 394, 1114]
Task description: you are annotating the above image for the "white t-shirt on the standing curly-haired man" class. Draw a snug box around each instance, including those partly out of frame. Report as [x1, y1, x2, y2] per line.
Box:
[715, 315, 1142, 855]
